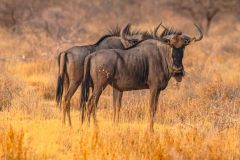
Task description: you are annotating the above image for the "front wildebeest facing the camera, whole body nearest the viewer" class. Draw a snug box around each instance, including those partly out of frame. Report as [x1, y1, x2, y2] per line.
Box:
[82, 25, 203, 131]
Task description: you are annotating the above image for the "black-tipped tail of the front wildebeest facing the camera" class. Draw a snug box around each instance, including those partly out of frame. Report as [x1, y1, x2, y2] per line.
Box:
[81, 55, 91, 102]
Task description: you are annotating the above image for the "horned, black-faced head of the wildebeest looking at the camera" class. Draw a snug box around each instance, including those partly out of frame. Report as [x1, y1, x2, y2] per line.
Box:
[154, 24, 203, 82]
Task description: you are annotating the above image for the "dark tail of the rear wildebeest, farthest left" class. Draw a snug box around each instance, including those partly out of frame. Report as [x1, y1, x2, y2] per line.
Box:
[56, 52, 67, 105]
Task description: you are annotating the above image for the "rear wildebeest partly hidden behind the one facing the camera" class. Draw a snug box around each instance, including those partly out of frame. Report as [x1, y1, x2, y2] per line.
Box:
[56, 24, 155, 125]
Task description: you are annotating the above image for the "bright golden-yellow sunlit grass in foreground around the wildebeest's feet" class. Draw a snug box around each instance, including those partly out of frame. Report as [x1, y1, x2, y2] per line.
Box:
[0, 110, 240, 159]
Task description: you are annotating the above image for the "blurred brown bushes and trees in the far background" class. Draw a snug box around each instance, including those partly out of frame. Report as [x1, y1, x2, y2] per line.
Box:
[0, 0, 240, 41]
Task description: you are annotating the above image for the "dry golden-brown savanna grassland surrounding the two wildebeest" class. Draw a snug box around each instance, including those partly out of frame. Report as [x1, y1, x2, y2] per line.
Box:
[0, 0, 240, 160]
